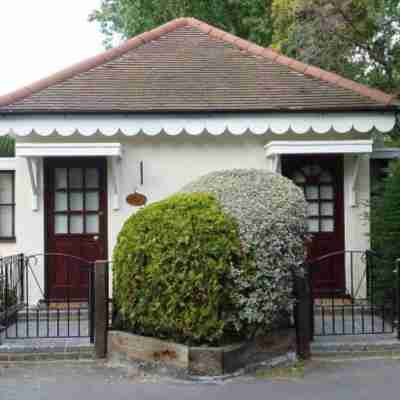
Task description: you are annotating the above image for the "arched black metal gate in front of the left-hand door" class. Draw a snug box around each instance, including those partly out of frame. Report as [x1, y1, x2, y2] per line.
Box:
[3, 253, 94, 343]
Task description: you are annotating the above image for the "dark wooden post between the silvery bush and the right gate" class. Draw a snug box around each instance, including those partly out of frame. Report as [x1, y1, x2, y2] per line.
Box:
[294, 274, 313, 360]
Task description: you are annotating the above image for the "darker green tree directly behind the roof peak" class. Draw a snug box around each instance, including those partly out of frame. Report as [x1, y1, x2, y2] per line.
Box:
[89, 0, 272, 46]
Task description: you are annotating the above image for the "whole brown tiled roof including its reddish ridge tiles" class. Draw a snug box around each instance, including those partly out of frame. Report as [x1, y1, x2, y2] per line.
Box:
[0, 18, 395, 113]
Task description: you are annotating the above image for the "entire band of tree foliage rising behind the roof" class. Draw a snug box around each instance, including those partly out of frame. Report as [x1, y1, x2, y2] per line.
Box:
[90, 0, 400, 92]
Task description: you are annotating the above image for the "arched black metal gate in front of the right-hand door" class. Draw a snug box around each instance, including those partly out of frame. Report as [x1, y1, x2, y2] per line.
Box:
[305, 251, 400, 338]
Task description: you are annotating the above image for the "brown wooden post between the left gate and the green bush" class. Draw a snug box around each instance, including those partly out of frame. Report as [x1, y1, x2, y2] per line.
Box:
[94, 261, 108, 358]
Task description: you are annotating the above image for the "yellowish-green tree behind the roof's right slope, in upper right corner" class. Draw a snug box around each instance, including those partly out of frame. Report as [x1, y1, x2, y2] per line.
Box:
[272, 0, 400, 92]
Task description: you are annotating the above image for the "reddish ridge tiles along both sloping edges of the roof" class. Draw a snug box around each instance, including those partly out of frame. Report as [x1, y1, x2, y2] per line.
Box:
[0, 17, 397, 107]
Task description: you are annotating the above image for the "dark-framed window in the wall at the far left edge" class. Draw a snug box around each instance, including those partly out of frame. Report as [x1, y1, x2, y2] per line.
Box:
[0, 171, 15, 240]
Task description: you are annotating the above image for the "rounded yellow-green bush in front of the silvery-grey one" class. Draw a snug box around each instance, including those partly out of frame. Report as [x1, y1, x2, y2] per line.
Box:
[113, 193, 241, 343]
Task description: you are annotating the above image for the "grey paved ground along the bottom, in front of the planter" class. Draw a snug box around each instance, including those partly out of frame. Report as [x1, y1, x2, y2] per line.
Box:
[0, 360, 400, 400]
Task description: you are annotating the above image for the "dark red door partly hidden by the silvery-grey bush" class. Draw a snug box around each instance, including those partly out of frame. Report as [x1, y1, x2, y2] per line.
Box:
[282, 155, 345, 296]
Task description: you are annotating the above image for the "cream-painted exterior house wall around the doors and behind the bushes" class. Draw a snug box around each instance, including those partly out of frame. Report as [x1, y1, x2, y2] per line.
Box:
[0, 134, 370, 301]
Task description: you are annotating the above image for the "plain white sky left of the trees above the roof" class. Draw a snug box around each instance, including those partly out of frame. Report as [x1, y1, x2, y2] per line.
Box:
[0, 0, 104, 95]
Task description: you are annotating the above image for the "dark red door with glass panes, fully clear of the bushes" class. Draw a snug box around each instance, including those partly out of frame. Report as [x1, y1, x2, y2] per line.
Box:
[45, 158, 107, 301]
